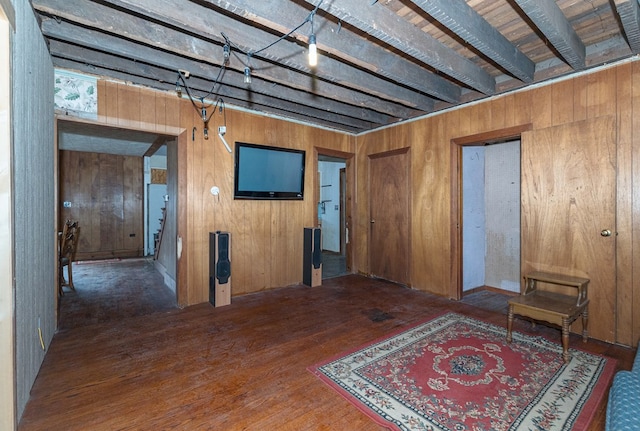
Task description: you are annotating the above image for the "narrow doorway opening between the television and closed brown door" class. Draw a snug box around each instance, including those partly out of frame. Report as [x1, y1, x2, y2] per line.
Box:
[316, 150, 352, 279]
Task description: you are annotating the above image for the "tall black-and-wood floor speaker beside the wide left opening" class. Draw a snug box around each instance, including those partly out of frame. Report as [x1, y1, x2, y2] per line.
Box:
[209, 231, 231, 307]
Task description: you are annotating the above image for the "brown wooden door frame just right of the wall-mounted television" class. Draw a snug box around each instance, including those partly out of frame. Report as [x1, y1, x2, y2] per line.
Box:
[312, 147, 357, 274]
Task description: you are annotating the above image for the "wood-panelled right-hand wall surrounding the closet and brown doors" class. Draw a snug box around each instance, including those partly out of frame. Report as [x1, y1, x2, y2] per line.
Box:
[354, 61, 640, 345]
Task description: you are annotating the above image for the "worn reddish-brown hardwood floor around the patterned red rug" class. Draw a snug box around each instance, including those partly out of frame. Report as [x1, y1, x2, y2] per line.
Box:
[19, 259, 634, 431]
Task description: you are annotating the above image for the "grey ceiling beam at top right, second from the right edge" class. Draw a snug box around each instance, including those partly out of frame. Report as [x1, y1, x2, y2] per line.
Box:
[515, 0, 586, 70]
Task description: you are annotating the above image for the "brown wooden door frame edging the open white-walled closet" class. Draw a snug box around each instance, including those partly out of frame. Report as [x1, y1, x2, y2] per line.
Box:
[448, 123, 533, 300]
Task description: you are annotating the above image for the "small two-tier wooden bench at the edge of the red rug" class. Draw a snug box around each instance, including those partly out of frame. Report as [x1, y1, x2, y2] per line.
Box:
[507, 271, 589, 363]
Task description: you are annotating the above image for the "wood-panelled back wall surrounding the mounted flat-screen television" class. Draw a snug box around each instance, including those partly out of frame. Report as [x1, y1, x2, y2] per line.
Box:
[98, 81, 356, 305]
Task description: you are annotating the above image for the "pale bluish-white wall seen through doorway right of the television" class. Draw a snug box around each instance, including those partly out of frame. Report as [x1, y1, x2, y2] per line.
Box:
[318, 161, 346, 253]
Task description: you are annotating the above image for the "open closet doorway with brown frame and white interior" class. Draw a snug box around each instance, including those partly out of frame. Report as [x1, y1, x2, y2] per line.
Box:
[449, 124, 532, 300]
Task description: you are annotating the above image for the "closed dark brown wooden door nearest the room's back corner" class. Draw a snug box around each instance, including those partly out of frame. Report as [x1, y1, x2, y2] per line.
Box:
[369, 148, 410, 285]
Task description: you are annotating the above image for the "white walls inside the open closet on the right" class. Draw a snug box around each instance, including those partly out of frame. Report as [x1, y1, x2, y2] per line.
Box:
[462, 141, 520, 292]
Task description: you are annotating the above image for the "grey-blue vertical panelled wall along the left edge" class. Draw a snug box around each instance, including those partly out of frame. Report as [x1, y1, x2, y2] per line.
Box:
[12, 1, 57, 418]
